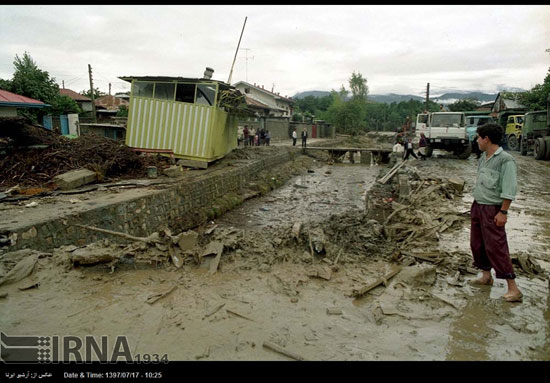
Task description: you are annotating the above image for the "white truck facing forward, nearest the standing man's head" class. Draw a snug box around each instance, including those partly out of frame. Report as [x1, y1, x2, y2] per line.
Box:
[415, 112, 472, 159]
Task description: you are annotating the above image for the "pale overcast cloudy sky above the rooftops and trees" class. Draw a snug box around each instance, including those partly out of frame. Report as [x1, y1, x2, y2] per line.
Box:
[0, 5, 550, 96]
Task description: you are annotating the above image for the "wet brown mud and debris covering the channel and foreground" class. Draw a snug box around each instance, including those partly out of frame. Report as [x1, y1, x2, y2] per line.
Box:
[0, 140, 550, 361]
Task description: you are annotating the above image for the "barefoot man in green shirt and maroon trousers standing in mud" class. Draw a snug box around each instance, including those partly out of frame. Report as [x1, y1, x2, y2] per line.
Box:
[470, 124, 523, 302]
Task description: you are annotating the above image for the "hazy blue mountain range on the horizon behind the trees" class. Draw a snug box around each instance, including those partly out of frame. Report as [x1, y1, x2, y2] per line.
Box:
[293, 90, 497, 104]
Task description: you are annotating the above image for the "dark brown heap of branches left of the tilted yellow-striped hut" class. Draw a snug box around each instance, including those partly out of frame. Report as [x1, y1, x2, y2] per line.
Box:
[0, 119, 169, 187]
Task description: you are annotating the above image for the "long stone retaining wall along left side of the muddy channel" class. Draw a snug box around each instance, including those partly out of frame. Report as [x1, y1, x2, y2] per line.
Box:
[0, 151, 294, 252]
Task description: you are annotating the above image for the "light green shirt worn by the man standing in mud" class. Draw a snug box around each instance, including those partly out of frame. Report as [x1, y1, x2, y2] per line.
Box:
[472, 147, 517, 205]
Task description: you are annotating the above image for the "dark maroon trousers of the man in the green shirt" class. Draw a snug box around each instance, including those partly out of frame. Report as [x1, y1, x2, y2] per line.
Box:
[470, 201, 516, 279]
